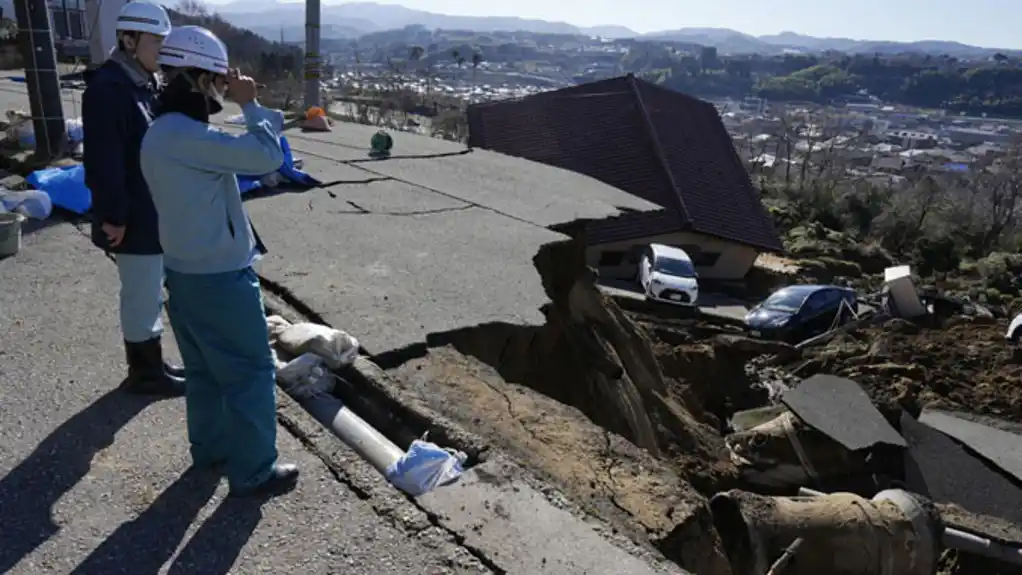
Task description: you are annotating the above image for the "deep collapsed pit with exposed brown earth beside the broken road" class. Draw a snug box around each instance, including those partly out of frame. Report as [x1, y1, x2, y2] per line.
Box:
[376, 231, 790, 575]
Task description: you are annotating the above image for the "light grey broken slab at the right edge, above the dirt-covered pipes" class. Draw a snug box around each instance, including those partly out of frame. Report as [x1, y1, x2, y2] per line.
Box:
[919, 409, 1022, 481]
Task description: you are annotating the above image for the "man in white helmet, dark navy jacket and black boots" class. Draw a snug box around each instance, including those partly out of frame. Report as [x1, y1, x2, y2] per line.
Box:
[82, 2, 184, 396]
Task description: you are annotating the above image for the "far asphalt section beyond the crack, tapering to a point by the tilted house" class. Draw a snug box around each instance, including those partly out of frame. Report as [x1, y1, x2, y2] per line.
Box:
[331, 142, 659, 227]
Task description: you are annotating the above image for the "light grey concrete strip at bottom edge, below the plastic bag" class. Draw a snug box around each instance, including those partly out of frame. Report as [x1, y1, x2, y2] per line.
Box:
[419, 462, 686, 575]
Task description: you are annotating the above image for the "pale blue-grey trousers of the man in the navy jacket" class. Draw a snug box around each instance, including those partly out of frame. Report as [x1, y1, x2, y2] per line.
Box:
[114, 253, 164, 343]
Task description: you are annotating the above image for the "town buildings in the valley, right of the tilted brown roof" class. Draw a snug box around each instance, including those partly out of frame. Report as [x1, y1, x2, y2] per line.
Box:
[717, 98, 1022, 187]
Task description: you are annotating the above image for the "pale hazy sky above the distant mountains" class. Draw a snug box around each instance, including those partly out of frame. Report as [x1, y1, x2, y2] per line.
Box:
[203, 0, 1022, 49]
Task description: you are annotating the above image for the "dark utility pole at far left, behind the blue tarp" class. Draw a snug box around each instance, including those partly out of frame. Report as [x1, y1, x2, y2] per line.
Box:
[14, 0, 66, 161]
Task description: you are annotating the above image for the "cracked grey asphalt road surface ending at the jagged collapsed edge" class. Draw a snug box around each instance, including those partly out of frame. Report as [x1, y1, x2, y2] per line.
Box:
[245, 142, 654, 354]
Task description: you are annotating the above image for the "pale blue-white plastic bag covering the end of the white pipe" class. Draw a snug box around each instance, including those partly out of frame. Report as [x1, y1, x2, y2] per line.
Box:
[386, 439, 467, 495]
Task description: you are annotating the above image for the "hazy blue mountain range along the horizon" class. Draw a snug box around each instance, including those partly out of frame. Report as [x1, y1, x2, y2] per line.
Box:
[217, 0, 1022, 57]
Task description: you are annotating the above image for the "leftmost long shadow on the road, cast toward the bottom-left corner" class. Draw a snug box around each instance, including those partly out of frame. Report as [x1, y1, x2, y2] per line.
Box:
[0, 389, 151, 573]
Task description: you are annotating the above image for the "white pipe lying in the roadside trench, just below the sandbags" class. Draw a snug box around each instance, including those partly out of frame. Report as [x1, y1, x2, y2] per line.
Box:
[292, 386, 405, 475]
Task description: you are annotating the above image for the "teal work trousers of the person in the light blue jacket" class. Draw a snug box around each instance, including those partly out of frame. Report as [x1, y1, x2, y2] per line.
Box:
[167, 268, 277, 489]
